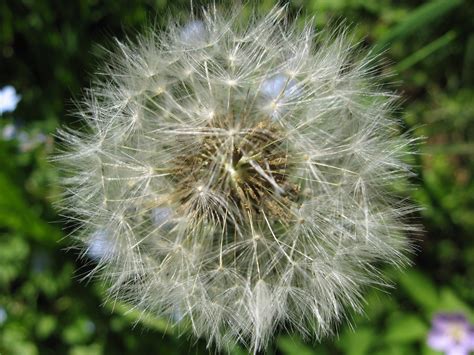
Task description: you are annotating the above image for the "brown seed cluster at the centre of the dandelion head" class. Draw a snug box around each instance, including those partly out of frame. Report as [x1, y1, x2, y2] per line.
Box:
[171, 113, 299, 227]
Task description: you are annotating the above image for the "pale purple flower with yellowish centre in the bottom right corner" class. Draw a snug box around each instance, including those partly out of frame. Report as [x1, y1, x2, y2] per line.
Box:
[428, 314, 474, 355]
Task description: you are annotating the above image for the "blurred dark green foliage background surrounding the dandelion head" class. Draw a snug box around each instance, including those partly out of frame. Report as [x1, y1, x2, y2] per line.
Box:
[0, 0, 474, 355]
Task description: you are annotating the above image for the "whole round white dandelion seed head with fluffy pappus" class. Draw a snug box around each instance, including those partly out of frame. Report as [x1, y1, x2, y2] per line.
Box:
[58, 8, 414, 352]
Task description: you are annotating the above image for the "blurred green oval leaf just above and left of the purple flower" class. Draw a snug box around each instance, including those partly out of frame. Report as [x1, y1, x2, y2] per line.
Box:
[399, 269, 439, 312]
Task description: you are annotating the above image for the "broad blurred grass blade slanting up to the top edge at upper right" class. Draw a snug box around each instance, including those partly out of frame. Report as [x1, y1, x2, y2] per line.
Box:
[372, 0, 462, 54]
